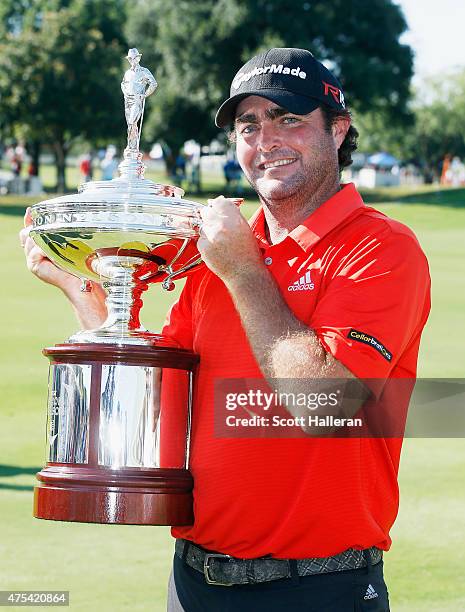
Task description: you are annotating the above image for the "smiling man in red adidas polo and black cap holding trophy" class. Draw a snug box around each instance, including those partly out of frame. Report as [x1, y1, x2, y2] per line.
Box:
[20, 49, 430, 612]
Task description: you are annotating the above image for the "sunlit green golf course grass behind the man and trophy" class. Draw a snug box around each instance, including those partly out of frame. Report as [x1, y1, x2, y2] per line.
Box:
[0, 188, 465, 612]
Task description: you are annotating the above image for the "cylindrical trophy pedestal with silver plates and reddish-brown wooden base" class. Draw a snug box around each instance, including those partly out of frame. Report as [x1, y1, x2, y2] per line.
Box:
[34, 344, 198, 525]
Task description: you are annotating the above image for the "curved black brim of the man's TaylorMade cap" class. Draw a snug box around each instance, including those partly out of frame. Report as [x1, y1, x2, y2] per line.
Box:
[215, 89, 321, 128]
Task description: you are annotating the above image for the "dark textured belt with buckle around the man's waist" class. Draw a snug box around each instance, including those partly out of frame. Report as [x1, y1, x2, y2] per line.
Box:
[175, 540, 383, 586]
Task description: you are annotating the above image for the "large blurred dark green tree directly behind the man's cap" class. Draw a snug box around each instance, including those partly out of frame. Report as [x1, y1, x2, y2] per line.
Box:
[126, 0, 412, 177]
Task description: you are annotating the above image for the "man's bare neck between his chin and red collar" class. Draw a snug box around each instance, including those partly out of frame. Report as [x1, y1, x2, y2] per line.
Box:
[260, 180, 341, 244]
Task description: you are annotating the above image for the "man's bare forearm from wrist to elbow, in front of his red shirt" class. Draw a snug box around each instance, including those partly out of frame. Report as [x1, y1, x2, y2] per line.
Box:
[221, 267, 368, 435]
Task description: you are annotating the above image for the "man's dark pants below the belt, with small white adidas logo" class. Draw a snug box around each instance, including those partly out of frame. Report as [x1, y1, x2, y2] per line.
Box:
[173, 555, 389, 612]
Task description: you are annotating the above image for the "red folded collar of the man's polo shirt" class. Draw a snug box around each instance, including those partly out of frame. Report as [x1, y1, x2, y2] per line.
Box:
[250, 183, 365, 251]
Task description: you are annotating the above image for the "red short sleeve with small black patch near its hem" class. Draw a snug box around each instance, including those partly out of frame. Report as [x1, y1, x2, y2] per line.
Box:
[310, 228, 430, 379]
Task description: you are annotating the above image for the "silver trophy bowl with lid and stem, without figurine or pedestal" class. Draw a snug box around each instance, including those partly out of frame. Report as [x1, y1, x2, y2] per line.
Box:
[30, 172, 202, 345]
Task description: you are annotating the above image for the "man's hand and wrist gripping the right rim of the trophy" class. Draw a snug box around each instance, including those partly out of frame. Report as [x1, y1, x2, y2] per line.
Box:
[197, 196, 263, 284]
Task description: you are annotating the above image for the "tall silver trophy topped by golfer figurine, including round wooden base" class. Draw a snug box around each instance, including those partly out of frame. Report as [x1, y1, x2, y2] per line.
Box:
[30, 49, 202, 525]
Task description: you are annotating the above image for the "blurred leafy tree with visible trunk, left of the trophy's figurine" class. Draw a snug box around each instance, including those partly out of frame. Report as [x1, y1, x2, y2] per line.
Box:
[0, 0, 127, 191]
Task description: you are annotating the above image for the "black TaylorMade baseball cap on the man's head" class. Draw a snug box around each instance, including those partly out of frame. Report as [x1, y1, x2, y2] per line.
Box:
[215, 48, 345, 127]
